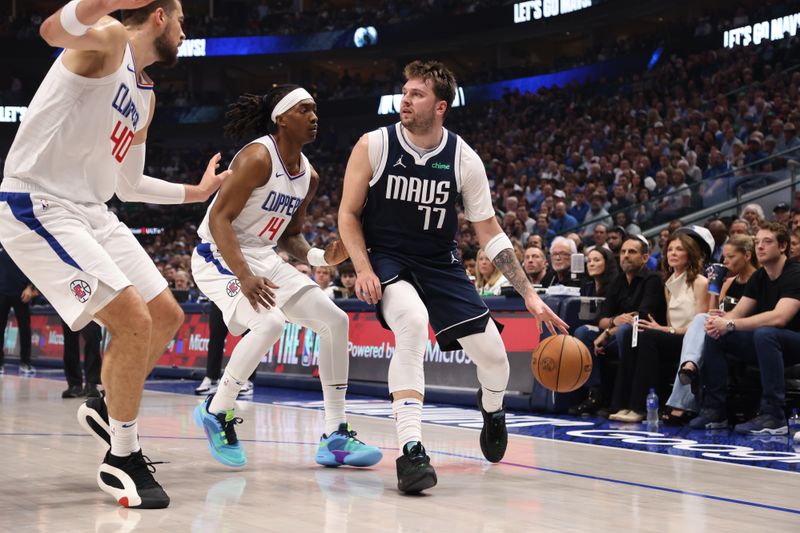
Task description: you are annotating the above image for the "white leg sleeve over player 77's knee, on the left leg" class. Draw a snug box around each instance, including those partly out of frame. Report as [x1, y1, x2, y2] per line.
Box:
[381, 281, 428, 395]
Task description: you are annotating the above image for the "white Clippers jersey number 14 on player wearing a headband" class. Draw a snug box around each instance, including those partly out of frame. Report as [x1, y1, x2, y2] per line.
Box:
[197, 135, 311, 249]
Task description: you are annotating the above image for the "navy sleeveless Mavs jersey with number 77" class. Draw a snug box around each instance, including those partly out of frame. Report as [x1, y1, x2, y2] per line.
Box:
[361, 123, 461, 256]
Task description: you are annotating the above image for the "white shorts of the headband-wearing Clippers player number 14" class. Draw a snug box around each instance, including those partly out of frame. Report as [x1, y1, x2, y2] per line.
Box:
[192, 242, 319, 335]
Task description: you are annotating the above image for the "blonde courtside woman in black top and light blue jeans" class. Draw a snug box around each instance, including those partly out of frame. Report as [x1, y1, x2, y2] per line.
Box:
[661, 235, 758, 426]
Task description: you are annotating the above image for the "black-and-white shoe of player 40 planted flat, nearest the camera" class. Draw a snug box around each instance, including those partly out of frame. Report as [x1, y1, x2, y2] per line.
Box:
[97, 450, 169, 509]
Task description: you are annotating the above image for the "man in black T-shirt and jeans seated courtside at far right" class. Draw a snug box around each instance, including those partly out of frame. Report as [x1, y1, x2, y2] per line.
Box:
[689, 223, 800, 435]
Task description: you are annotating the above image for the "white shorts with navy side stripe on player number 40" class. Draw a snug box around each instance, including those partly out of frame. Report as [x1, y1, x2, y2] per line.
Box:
[0, 178, 167, 331]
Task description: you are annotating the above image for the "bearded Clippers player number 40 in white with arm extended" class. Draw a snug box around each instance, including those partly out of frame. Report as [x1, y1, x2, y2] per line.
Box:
[0, 0, 227, 508]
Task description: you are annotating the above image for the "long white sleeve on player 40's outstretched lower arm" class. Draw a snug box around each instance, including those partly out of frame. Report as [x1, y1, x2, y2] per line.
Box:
[116, 143, 186, 204]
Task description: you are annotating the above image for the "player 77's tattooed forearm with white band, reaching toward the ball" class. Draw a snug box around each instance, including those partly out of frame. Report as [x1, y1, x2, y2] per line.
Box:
[472, 217, 569, 335]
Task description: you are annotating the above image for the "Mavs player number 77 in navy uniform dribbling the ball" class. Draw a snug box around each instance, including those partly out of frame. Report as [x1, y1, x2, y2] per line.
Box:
[339, 61, 567, 493]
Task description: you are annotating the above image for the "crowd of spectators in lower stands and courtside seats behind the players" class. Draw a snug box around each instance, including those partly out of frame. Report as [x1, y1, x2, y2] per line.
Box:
[1, 2, 800, 433]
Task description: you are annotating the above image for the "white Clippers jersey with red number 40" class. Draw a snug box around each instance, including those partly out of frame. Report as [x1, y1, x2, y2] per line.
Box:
[5, 45, 153, 203]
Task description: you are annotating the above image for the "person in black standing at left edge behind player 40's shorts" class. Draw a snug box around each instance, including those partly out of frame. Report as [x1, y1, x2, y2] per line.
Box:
[0, 247, 39, 376]
